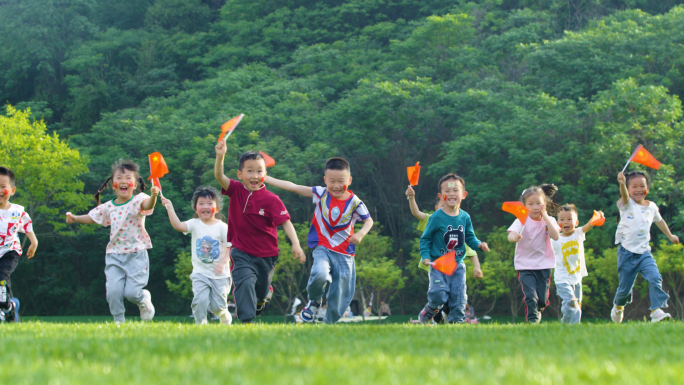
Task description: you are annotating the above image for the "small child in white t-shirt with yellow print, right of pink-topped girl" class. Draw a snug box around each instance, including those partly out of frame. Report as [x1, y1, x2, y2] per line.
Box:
[551, 204, 603, 324]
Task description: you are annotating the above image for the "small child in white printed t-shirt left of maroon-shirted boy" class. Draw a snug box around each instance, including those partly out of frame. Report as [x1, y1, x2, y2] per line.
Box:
[162, 187, 233, 325]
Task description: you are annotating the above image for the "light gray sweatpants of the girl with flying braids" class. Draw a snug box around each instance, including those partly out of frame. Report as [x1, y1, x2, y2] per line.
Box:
[105, 250, 150, 322]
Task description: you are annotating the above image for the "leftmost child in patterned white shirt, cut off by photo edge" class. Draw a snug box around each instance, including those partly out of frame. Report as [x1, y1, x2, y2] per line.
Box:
[0, 167, 38, 323]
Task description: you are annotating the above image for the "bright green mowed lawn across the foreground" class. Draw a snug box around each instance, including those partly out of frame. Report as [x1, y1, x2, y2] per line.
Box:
[0, 321, 684, 385]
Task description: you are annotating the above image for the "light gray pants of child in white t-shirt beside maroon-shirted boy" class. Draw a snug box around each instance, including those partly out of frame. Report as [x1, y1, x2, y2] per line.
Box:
[190, 273, 231, 325]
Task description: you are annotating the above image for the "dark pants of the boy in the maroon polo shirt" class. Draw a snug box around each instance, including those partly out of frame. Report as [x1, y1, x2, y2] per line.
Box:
[230, 247, 278, 322]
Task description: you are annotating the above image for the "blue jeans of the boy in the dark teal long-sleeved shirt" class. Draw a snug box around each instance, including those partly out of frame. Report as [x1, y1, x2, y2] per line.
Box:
[428, 262, 468, 323]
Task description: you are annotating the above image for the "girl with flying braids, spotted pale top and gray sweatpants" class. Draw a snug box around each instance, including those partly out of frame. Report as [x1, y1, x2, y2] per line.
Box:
[66, 159, 159, 324]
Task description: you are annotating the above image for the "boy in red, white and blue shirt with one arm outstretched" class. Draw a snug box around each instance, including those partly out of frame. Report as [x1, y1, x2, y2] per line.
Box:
[266, 158, 373, 324]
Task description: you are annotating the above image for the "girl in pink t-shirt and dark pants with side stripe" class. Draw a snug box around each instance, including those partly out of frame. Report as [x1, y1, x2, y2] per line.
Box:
[508, 184, 560, 323]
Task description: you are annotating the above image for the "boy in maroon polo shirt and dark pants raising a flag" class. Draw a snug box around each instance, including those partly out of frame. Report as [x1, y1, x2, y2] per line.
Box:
[214, 140, 306, 323]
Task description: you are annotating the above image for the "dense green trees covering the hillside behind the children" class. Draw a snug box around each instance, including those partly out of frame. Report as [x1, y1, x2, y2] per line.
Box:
[0, 0, 684, 317]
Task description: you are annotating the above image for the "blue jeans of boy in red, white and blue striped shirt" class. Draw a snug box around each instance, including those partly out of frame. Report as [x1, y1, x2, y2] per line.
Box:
[306, 246, 356, 324]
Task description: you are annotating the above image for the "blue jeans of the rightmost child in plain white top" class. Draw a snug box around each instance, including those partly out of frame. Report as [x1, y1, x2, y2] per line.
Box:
[613, 245, 670, 311]
